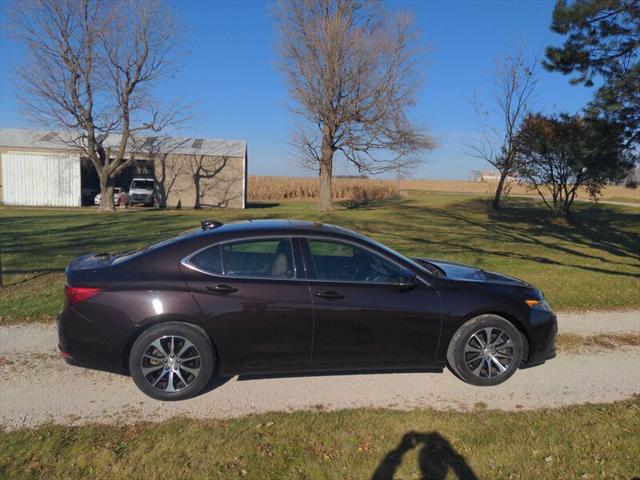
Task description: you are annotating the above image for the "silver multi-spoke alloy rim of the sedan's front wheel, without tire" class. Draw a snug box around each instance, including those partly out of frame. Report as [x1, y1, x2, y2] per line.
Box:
[464, 327, 514, 378]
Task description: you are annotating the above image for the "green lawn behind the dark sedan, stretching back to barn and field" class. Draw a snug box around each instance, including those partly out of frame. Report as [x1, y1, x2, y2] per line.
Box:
[0, 192, 640, 323]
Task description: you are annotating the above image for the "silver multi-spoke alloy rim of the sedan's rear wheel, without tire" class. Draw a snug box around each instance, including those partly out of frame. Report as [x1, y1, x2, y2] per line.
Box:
[140, 335, 201, 392]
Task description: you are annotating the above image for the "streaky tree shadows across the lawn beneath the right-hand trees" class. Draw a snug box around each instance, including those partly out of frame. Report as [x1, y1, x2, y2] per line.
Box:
[366, 198, 640, 278]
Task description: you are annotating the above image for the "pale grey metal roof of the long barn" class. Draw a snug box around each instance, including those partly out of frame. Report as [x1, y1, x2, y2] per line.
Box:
[0, 128, 247, 157]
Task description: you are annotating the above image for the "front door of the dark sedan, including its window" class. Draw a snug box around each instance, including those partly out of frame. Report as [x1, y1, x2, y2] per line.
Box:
[302, 238, 441, 368]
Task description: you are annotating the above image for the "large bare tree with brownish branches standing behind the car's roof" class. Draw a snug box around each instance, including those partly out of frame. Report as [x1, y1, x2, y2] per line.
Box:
[275, 0, 434, 210]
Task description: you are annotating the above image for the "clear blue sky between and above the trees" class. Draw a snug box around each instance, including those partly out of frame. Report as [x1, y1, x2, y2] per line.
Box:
[0, 0, 592, 179]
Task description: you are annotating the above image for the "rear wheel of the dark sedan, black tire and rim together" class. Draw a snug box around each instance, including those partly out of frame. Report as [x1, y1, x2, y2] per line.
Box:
[129, 322, 215, 400]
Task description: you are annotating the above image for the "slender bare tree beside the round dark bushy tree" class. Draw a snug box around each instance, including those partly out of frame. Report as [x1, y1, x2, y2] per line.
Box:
[470, 51, 538, 210]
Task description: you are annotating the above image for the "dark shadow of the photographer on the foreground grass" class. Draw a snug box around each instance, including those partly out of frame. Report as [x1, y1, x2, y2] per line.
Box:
[371, 432, 478, 480]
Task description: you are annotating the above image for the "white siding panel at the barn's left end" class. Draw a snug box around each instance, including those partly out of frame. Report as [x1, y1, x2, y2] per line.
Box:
[1, 152, 82, 207]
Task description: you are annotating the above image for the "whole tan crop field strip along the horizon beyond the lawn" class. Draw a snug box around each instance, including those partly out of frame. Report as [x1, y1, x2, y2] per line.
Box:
[248, 176, 640, 203]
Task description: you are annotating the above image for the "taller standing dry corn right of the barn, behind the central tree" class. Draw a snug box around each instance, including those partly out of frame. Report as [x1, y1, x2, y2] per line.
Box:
[248, 176, 398, 201]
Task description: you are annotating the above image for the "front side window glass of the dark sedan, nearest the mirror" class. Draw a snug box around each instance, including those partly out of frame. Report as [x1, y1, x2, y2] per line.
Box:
[307, 239, 403, 283]
